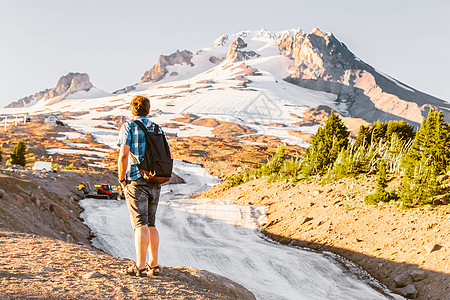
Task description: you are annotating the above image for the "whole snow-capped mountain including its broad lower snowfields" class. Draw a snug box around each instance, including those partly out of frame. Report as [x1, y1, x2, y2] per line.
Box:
[0, 29, 450, 146]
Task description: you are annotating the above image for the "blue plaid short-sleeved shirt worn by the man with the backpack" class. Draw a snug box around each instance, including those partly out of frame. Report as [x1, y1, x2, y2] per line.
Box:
[117, 116, 164, 181]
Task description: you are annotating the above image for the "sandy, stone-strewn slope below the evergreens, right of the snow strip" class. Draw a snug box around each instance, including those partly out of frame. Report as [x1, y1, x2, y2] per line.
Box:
[196, 177, 450, 300]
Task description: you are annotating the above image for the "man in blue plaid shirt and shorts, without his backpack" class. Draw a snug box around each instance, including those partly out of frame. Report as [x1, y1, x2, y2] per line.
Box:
[118, 96, 167, 277]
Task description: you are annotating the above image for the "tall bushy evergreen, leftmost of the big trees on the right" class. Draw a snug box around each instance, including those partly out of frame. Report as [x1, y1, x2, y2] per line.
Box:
[303, 111, 349, 175]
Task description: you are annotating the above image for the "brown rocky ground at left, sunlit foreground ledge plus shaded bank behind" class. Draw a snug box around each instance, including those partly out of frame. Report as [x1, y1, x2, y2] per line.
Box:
[0, 170, 254, 299]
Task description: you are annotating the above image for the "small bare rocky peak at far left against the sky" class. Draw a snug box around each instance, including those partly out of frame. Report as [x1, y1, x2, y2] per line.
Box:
[6, 73, 93, 107]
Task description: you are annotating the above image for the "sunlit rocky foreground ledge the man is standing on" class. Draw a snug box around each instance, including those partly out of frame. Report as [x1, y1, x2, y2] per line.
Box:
[0, 231, 255, 299]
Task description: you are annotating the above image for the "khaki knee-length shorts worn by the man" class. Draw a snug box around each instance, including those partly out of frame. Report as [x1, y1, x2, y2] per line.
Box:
[124, 178, 161, 229]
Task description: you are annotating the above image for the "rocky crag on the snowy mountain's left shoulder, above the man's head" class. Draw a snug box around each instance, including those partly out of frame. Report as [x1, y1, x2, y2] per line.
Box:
[140, 50, 194, 83]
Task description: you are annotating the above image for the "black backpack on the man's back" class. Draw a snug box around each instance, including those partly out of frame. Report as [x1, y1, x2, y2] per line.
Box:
[134, 120, 173, 183]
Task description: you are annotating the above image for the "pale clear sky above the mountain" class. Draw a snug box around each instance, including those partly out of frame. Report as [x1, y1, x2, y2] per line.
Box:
[0, 0, 450, 107]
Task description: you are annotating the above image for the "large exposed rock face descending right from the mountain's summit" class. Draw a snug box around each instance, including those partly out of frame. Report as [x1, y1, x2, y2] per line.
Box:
[279, 29, 450, 125]
